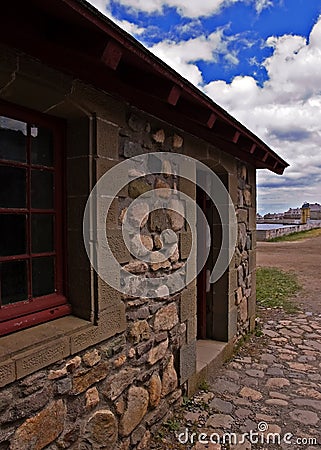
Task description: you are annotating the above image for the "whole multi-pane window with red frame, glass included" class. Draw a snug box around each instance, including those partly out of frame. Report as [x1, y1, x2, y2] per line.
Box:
[0, 105, 70, 336]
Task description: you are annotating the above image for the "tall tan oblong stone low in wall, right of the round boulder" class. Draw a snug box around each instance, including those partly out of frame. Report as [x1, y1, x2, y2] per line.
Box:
[119, 386, 149, 436]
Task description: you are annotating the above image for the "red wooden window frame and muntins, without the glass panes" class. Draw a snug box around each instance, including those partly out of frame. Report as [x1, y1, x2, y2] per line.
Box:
[0, 101, 71, 336]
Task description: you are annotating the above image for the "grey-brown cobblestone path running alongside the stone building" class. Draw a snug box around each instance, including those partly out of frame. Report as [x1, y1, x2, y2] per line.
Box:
[151, 310, 321, 450]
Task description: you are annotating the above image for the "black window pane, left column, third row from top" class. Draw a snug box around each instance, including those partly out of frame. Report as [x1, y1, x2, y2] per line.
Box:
[0, 214, 27, 256]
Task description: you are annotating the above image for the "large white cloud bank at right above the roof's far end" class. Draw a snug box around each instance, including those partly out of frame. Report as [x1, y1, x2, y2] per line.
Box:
[204, 16, 321, 213]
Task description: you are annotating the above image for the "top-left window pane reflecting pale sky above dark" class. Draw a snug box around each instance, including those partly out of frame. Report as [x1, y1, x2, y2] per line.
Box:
[0, 116, 27, 162]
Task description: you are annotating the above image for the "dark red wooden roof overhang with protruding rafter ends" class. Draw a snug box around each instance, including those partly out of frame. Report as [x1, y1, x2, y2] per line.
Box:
[0, 0, 288, 174]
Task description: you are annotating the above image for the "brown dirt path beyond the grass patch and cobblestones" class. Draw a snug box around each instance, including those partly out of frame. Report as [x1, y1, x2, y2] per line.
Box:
[257, 236, 321, 313]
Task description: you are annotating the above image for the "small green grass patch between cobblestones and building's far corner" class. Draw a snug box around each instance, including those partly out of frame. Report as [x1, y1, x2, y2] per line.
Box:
[256, 267, 300, 313]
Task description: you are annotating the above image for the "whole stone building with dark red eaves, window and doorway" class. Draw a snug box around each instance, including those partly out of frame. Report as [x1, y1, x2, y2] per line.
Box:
[0, 0, 287, 450]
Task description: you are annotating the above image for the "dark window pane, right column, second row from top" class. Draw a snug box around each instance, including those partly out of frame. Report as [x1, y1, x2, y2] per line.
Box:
[31, 170, 54, 209]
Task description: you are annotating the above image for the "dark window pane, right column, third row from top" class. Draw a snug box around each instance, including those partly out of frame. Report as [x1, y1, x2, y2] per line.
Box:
[31, 214, 54, 253]
